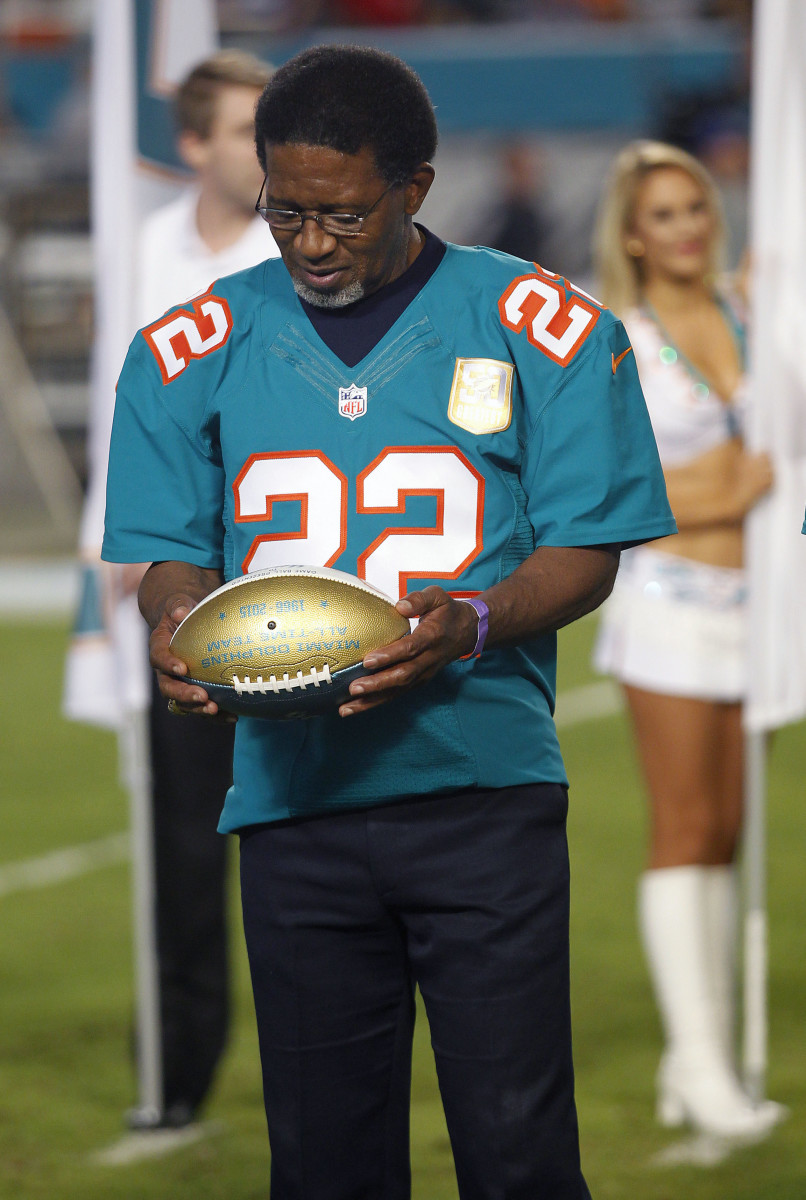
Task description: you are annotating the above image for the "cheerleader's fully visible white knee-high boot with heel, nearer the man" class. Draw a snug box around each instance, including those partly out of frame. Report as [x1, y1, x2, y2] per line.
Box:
[639, 866, 783, 1138]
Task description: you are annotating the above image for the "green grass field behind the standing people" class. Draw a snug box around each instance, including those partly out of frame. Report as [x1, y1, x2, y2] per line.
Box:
[0, 622, 806, 1200]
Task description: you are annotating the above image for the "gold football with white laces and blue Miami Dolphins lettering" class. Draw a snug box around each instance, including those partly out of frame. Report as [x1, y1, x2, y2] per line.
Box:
[170, 566, 410, 718]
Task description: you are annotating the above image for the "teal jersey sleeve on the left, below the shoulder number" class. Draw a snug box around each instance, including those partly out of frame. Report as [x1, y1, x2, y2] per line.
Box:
[101, 350, 224, 569]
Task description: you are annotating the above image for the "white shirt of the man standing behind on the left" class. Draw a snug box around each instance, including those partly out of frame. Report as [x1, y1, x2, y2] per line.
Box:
[136, 188, 279, 328]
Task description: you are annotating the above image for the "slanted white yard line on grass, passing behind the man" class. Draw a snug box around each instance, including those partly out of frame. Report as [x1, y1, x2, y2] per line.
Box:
[0, 680, 621, 899]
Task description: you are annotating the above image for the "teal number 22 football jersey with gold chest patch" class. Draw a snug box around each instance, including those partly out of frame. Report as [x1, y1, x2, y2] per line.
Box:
[103, 238, 675, 830]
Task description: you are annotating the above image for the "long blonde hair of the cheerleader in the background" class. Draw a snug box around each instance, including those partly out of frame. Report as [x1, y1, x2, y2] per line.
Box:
[594, 140, 724, 316]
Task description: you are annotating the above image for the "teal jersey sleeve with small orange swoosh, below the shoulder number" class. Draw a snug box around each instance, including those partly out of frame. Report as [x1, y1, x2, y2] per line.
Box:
[518, 313, 676, 546]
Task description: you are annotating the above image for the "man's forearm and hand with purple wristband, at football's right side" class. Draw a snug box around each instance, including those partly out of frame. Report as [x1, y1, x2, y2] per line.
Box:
[338, 546, 619, 716]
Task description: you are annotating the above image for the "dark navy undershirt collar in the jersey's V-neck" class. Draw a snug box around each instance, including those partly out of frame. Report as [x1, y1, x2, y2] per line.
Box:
[299, 224, 446, 367]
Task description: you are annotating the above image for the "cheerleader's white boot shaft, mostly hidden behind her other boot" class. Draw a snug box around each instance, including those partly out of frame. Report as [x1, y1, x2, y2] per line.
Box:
[703, 864, 739, 1062]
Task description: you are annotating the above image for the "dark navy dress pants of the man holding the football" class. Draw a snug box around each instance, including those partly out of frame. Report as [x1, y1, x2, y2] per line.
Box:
[241, 784, 590, 1200]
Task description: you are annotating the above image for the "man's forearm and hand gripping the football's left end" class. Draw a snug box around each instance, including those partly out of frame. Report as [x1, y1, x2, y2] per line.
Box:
[138, 563, 235, 721]
